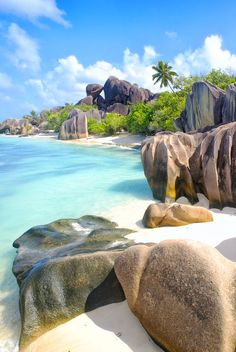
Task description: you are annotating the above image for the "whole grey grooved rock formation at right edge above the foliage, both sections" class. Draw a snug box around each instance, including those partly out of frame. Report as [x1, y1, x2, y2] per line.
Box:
[175, 81, 236, 132]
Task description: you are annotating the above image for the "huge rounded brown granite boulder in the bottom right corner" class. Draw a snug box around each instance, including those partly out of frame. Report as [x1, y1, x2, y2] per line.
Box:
[115, 240, 236, 352]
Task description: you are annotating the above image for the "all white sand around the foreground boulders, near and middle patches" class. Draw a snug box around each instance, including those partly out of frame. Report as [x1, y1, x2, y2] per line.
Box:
[24, 194, 236, 352]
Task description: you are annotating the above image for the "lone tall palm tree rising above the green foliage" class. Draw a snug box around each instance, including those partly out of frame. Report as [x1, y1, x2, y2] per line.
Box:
[152, 61, 178, 92]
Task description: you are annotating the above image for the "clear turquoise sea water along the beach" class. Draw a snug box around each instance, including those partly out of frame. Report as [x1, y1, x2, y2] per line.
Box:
[0, 137, 151, 352]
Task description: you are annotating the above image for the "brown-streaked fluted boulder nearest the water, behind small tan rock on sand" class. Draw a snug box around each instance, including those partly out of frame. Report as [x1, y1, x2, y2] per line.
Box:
[142, 132, 202, 202]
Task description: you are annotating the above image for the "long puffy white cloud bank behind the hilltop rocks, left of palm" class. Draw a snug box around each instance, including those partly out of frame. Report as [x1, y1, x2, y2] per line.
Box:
[27, 46, 158, 106]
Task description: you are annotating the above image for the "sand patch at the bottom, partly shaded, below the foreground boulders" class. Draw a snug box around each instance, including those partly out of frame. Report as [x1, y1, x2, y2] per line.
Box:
[24, 301, 162, 352]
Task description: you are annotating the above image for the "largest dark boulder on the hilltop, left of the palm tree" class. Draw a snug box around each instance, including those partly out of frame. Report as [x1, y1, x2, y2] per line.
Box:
[104, 76, 154, 106]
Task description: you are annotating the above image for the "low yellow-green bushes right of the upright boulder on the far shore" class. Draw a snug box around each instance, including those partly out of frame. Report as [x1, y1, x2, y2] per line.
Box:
[88, 113, 126, 136]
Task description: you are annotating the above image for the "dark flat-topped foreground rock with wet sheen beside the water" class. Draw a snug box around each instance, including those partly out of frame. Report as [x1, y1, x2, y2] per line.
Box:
[13, 216, 133, 346]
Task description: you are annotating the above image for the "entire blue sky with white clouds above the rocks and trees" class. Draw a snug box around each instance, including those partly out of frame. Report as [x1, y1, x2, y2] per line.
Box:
[0, 0, 236, 121]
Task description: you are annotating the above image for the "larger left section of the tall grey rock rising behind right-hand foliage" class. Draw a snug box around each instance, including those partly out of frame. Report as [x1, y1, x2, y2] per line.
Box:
[176, 81, 226, 132]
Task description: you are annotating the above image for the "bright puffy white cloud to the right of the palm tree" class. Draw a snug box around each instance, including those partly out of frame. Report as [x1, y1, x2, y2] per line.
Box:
[172, 35, 236, 75]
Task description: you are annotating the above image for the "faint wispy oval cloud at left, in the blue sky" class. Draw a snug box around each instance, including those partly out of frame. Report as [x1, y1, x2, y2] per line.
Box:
[7, 23, 41, 72]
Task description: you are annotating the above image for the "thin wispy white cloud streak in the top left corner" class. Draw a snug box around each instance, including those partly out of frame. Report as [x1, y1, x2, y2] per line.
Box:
[0, 0, 69, 27]
